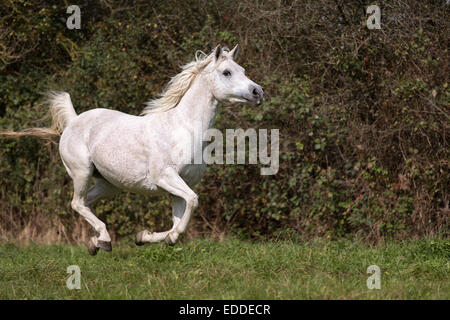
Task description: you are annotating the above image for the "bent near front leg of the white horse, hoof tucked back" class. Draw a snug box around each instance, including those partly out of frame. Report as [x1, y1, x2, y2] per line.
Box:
[135, 168, 198, 245]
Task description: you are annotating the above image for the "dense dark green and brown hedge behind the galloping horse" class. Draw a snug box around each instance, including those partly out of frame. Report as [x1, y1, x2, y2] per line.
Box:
[0, 0, 450, 241]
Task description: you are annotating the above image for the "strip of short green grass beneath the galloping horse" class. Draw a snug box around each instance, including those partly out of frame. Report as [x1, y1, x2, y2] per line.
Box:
[0, 239, 450, 299]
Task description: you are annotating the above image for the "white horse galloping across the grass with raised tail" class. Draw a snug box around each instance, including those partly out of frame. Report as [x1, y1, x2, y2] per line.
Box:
[0, 45, 263, 255]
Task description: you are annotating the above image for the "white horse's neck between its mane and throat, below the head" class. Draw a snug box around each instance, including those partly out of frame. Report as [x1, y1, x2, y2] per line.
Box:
[170, 74, 217, 133]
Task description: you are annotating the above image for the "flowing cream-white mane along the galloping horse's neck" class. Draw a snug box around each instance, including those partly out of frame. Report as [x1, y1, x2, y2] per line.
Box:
[141, 51, 214, 116]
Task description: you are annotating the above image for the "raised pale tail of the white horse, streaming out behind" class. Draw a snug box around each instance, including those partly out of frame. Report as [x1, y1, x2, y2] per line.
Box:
[0, 91, 77, 140]
